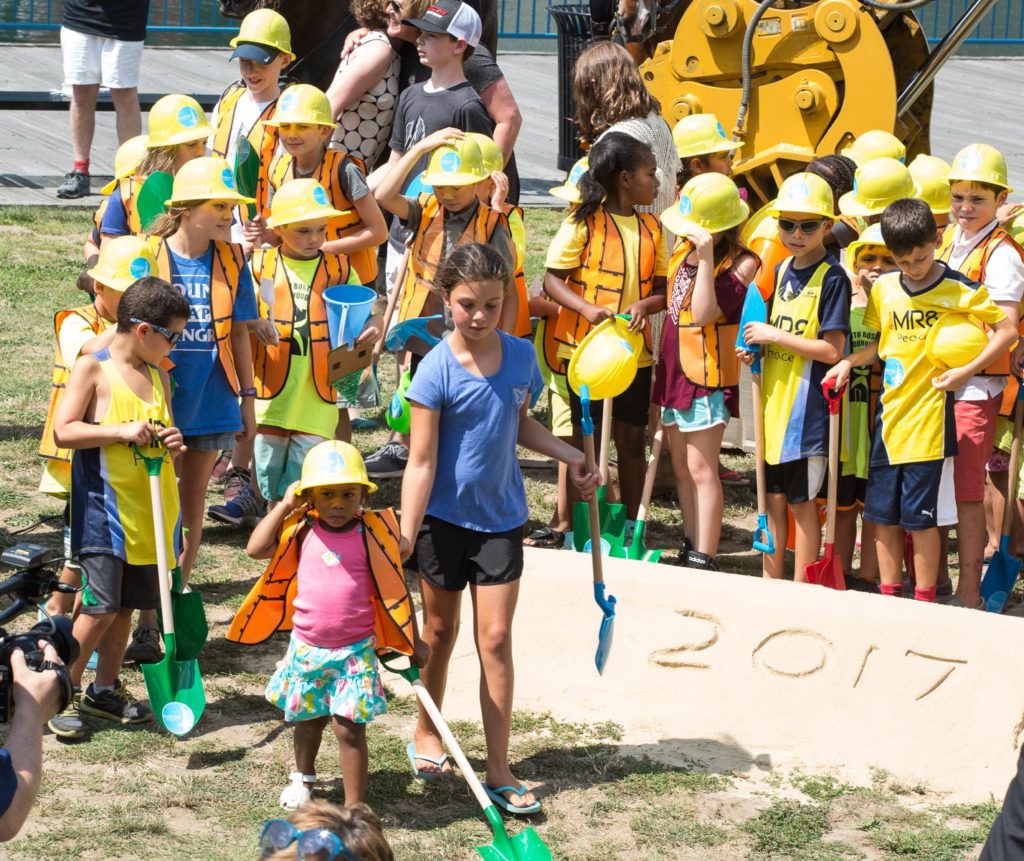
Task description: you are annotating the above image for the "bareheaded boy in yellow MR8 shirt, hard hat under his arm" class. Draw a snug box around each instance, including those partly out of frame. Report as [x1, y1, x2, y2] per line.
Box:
[825, 200, 1017, 602]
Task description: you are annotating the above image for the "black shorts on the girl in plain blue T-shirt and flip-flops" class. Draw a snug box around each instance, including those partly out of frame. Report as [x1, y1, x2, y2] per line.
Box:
[409, 514, 522, 592]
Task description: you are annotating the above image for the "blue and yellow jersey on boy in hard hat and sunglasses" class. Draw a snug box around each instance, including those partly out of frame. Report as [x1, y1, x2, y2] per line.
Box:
[761, 256, 850, 464]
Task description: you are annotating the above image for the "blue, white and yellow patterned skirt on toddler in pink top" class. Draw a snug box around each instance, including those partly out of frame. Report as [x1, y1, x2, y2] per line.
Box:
[264, 634, 387, 724]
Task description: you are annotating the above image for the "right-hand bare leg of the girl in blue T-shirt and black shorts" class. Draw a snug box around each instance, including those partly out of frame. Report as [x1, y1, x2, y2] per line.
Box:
[469, 581, 540, 807]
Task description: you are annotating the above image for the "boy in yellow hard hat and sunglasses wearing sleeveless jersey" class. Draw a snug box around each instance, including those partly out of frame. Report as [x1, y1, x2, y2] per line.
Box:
[738, 170, 851, 583]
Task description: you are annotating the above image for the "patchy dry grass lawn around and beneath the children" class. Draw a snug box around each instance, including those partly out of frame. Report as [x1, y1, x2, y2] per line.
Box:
[0, 208, 998, 861]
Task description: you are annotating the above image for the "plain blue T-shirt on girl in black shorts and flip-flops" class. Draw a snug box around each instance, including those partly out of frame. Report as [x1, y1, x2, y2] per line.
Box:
[408, 332, 544, 532]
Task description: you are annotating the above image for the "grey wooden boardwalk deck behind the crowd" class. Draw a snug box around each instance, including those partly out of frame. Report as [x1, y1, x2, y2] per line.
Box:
[0, 45, 1024, 209]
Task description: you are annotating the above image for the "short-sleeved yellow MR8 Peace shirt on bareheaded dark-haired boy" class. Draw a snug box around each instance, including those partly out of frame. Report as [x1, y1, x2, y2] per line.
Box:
[863, 263, 1006, 466]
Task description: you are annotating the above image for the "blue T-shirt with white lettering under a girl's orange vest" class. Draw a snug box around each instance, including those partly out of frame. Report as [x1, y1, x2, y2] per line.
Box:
[168, 244, 258, 436]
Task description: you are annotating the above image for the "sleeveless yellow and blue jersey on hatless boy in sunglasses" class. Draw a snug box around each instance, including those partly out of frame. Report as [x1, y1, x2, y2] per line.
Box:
[71, 350, 181, 565]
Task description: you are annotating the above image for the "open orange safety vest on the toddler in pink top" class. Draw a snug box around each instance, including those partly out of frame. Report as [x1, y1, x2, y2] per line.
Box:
[224, 508, 416, 655]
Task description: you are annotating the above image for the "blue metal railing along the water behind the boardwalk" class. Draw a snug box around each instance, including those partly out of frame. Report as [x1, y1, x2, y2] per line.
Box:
[0, 0, 1024, 45]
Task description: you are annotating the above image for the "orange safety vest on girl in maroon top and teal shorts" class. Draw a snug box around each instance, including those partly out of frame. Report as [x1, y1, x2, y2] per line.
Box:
[669, 236, 739, 389]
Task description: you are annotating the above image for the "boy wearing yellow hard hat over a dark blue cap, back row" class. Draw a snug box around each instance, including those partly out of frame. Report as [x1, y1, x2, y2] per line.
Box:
[210, 9, 295, 245]
